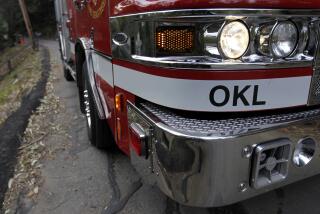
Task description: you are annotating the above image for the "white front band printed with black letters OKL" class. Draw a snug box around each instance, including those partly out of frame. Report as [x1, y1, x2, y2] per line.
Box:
[113, 65, 311, 112]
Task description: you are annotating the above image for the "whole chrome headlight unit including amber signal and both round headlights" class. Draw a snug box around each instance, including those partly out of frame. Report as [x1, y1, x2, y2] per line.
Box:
[111, 9, 320, 70]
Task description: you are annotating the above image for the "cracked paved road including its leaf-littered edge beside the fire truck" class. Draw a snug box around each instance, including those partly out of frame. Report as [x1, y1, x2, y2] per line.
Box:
[4, 41, 320, 214]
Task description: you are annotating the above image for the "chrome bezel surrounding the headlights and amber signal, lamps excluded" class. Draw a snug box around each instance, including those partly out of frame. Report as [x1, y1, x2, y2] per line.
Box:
[111, 9, 320, 70]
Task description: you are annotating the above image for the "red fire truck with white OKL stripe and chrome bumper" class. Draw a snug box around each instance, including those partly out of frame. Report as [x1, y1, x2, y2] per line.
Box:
[55, 0, 320, 207]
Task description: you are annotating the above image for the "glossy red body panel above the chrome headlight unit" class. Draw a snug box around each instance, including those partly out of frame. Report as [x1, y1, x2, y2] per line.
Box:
[110, 0, 320, 16]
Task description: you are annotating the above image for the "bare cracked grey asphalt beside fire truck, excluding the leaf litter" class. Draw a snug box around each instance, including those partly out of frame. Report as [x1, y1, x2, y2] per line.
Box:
[30, 41, 320, 214]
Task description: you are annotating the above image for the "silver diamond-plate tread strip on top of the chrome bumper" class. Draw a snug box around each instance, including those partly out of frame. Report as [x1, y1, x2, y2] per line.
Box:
[141, 103, 320, 137]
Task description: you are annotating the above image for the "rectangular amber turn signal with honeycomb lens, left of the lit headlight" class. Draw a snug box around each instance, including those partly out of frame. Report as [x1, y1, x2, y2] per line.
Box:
[156, 26, 195, 54]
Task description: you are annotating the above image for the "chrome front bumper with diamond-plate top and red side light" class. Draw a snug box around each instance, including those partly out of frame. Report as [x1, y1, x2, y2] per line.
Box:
[128, 103, 320, 207]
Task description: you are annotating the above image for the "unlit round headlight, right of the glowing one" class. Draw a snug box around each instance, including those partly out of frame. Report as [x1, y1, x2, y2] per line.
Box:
[271, 22, 298, 58]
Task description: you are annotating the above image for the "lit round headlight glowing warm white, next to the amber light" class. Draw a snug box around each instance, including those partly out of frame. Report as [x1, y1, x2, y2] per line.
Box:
[219, 21, 249, 59]
